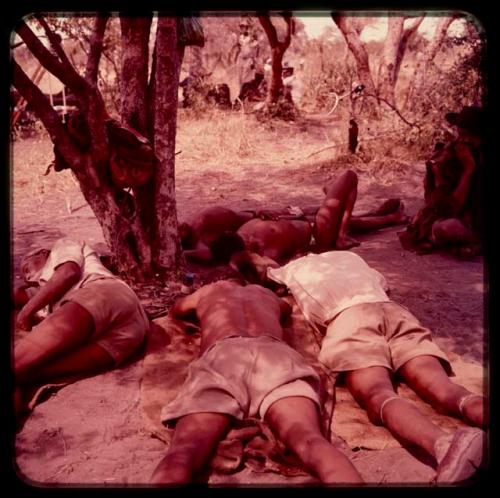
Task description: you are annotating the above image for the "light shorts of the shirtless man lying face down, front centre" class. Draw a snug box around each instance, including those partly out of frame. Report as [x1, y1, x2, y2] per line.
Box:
[161, 336, 321, 424]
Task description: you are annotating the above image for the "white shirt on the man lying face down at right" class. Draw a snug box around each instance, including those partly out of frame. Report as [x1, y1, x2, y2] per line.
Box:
[267, 251, 390, 326]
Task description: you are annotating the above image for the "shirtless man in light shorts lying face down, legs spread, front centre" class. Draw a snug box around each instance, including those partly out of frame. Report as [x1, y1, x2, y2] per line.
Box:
[150, 279, 362, 484]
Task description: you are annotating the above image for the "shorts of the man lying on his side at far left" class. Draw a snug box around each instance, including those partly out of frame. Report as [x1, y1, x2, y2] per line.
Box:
[64, 278, 149, 365]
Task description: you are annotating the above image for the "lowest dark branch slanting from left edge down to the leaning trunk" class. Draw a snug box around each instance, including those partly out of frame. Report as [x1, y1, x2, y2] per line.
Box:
[12, 60, 83, 169]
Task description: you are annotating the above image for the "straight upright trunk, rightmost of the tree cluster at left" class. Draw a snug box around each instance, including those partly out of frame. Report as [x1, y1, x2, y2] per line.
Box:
[153, 17, 183, 273]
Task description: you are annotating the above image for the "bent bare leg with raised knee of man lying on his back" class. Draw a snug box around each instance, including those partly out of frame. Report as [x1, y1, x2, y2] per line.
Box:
[314, 171, 359, 252]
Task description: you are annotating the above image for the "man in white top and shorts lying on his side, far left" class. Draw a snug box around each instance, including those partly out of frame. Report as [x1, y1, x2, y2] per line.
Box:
[14, 238, 149, 411]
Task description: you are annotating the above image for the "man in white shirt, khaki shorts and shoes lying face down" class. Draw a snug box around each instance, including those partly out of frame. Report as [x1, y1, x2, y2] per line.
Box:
[231, 251, 488, 482]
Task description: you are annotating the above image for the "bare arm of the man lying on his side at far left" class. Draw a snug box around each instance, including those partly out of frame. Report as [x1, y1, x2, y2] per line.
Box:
[17, 261, 82, 330]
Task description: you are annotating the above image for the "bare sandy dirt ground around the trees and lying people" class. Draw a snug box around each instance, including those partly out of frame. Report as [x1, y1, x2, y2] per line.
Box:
[11, 111, 487, 486]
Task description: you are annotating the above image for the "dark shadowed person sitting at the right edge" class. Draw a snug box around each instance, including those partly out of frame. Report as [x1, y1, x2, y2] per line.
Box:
[399, 107, 484, 258]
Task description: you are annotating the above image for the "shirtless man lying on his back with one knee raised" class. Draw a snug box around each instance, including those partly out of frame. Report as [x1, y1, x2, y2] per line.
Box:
[210, 171, 408, 263]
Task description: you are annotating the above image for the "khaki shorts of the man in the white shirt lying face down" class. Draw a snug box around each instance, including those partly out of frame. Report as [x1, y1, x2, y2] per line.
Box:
[318, 302, 451, 373]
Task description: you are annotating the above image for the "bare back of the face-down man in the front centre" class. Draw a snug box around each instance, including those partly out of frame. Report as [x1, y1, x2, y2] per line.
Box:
[172, 281, 289, 352]
